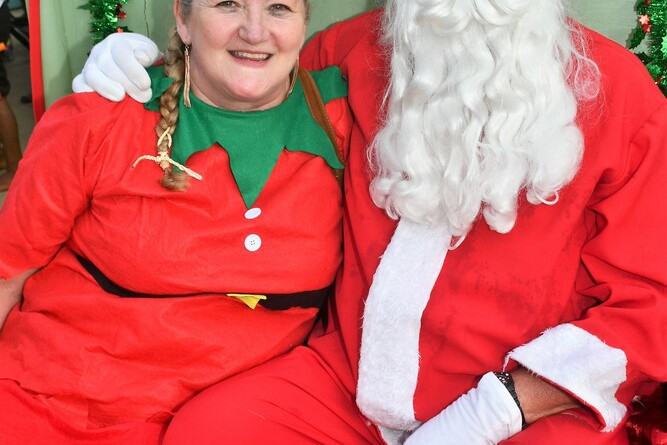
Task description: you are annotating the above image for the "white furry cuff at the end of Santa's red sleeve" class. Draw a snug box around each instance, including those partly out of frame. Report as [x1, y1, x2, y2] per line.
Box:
[506, 324, 627, 432]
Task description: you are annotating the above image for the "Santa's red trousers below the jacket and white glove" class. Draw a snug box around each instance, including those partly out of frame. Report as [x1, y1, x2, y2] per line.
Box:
[162, 347, 628, 445]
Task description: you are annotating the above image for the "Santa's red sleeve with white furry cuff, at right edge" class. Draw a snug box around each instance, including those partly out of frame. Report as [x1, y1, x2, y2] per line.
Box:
[507, 41, 667, 431]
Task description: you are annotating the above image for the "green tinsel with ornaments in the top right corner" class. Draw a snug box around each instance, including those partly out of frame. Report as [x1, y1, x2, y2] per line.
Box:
[629, 0, 667, 96]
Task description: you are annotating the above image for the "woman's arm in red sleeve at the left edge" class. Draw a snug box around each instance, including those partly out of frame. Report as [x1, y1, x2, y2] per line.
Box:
[0, 95, 111, 310]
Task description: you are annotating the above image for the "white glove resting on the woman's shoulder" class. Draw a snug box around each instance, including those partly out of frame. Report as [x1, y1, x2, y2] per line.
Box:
[72, 32, 161, 103]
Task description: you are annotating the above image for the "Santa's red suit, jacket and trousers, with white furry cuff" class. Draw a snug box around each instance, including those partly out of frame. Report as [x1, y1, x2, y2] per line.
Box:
[165, 10, 667, 445]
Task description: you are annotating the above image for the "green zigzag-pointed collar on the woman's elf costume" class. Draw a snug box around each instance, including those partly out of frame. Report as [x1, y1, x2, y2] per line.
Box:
[146, 67, 347, 208]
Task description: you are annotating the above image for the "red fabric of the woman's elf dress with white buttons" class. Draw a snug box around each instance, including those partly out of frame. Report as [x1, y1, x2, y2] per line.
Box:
[0, 73, 350, 445]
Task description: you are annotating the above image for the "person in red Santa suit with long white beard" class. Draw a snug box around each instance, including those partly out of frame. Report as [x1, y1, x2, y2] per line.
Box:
[73, 0, 667, 445]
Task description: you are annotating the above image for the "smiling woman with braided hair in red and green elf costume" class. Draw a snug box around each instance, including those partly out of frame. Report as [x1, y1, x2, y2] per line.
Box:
[0, 0, 350, 445]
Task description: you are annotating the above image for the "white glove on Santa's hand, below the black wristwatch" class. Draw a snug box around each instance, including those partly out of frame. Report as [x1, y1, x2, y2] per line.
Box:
[405, 372, 521, 445]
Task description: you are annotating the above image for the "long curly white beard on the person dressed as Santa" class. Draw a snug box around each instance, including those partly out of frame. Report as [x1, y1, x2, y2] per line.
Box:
[370, 0, 599, 236]
